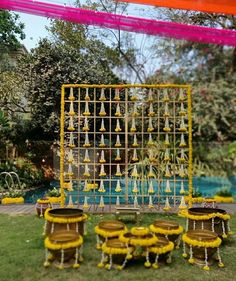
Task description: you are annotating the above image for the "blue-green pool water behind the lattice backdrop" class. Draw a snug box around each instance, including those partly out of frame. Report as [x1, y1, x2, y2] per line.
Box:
[25, 177, 236, 204]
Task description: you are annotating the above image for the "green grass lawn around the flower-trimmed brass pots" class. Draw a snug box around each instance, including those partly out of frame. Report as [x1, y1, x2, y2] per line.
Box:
[0, 214, 236, 281]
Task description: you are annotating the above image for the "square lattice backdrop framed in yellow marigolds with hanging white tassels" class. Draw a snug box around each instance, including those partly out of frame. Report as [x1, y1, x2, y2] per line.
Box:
[60, 84, 192, 212]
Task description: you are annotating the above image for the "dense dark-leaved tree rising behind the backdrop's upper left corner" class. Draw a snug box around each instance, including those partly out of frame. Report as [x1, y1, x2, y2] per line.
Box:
[20, 39, 119, 139]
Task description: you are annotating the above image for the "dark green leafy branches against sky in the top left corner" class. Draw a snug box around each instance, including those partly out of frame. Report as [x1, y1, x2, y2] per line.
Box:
[0, 10, 25, 52]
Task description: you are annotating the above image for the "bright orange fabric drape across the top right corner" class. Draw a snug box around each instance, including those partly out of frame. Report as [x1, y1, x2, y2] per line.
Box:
[119, 0, 236, 15]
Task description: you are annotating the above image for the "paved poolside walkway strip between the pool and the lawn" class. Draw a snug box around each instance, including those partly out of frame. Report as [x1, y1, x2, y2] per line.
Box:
[0, 203, 236, 215]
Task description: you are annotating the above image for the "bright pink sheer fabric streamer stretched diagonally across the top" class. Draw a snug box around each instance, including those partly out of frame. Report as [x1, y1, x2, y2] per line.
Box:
[0, 0, 236, 46]
